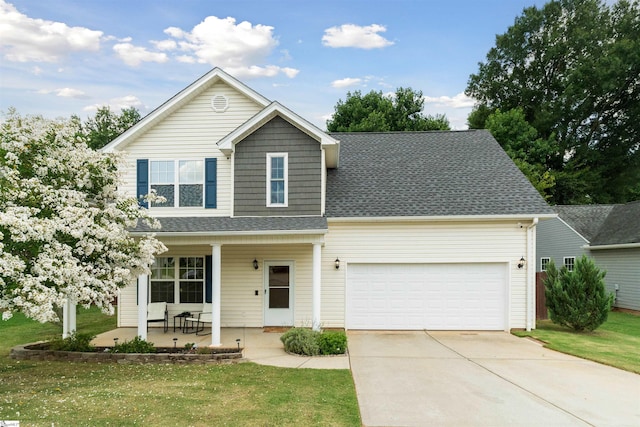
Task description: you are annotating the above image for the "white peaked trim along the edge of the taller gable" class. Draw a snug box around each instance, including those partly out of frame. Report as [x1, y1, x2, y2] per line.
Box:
[102, 68, 270, 152]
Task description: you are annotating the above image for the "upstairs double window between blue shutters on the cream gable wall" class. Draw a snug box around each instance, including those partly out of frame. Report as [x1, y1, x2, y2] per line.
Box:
[149, 160, 204, 207]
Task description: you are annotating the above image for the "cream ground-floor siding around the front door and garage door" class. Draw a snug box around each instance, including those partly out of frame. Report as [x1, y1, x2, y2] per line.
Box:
[119, 219, 534, 328]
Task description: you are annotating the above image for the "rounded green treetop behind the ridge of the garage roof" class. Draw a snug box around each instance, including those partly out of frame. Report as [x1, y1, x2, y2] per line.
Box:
[327, 88, 450, 132]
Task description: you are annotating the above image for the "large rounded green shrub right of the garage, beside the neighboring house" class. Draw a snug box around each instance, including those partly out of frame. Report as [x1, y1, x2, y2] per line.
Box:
[544, 255, 614, 332]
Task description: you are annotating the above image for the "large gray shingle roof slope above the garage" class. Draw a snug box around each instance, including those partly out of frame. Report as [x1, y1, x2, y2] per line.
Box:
[327, 130, 553, 217]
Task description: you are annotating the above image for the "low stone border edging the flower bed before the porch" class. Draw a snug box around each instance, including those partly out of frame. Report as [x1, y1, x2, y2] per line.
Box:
[9, 342, 246, 364]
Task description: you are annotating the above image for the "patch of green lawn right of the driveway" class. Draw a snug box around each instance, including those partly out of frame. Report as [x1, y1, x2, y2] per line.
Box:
[514, 311, 640, 374]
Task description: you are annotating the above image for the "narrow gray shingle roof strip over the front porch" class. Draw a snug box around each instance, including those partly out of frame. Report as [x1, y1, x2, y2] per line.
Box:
[132, 217, 328, 234]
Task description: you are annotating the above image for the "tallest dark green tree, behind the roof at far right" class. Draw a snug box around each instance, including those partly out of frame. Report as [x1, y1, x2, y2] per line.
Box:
[466, 0, 640, 204]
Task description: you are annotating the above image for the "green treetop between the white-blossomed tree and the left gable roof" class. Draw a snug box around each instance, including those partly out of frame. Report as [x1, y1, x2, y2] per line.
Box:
[78, 106, 141, 150]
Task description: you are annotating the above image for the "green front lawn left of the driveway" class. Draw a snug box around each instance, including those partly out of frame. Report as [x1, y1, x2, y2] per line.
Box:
[0, 309, 361, 427]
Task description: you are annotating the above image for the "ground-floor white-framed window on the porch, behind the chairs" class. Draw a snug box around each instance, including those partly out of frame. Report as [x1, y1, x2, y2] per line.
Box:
[150, 257, 204, 304]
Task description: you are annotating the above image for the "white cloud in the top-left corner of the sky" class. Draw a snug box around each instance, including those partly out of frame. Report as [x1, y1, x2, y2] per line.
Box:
[0, 0, 103, 62]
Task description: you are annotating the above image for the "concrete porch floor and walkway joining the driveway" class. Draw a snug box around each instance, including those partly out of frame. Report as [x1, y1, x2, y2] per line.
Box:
[92, 327, 351, 369]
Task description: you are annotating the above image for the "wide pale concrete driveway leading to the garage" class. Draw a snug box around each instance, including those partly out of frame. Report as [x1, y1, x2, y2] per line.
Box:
[348, 331, 640, 427]
